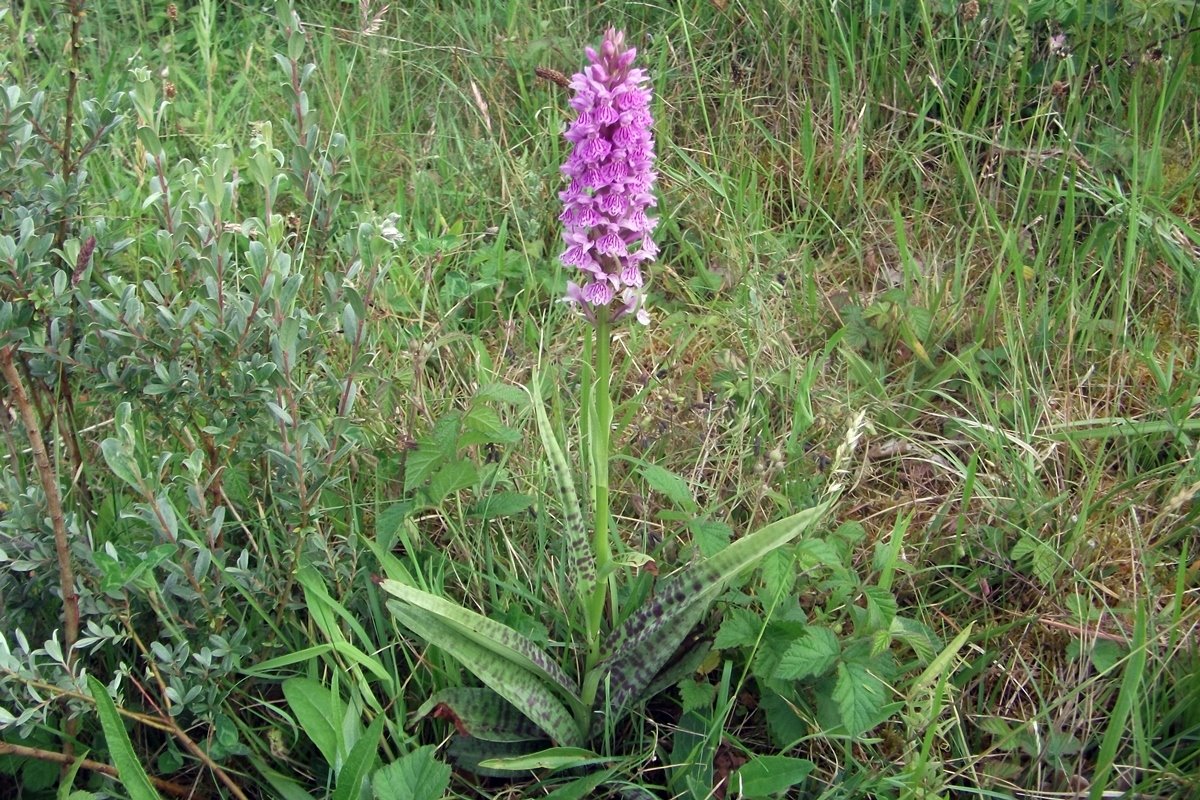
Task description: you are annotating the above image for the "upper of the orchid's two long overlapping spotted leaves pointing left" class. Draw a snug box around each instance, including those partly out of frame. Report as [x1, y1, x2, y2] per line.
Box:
[379, 579, 580, 704]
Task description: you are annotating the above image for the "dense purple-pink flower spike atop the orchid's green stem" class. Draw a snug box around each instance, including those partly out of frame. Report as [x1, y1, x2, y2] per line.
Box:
[558, 28, 659, 325]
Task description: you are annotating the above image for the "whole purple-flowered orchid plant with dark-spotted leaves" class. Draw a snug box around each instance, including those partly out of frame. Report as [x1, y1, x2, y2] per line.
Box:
[380, 30, 839, 769]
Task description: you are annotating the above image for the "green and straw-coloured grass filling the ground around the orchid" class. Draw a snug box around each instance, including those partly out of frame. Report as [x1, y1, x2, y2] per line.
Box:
[0, 0, 1200, 799]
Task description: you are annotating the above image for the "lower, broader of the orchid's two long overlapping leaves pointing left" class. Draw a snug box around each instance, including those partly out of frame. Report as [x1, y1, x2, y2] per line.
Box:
[388, 602, 582, 747]
